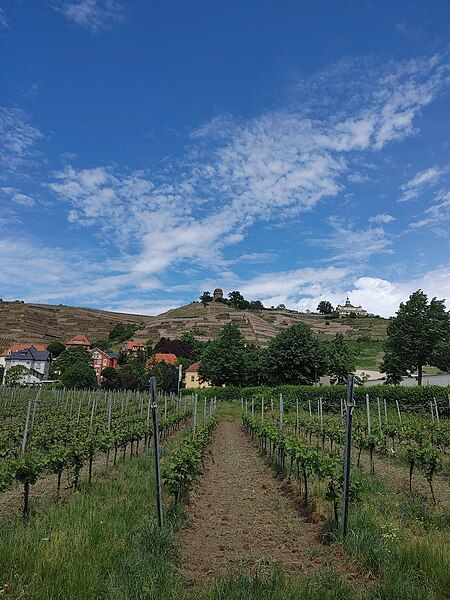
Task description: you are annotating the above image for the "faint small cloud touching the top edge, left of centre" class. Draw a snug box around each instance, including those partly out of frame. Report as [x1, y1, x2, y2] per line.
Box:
[57, 0, 123, 33]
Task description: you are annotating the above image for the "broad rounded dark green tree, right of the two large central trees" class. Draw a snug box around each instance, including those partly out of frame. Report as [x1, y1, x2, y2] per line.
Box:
[266, 323, 327, 385]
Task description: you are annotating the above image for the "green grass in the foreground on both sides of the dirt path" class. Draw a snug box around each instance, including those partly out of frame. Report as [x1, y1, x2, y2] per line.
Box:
[0, 403, 450, 600]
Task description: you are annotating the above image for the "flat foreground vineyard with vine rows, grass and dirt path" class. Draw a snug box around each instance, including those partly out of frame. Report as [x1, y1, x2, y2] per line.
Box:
[0, 388, 450, 600]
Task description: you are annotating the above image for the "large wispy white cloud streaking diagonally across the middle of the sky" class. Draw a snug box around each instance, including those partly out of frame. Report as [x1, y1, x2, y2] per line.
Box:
[50, 50, 447, 288]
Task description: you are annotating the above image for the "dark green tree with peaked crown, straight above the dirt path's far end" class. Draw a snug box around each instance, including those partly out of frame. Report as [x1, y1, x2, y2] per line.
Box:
[199, 323, 245, 385]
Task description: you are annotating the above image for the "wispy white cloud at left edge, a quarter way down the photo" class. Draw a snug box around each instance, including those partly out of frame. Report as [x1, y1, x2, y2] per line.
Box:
[0, 107, 43, 170]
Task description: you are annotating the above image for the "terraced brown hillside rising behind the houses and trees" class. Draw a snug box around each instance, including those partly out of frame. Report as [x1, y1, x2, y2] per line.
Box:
[0, 302, 387, 368]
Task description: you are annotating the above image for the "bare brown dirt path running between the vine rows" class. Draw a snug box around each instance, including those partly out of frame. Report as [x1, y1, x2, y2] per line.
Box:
[179, 422, 360, 582]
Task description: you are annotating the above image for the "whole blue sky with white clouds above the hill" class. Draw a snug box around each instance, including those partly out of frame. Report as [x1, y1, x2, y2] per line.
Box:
[0, 0, 450, 315]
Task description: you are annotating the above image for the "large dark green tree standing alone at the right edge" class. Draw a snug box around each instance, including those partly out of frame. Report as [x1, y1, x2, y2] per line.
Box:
[381, 290, 450, 385]
